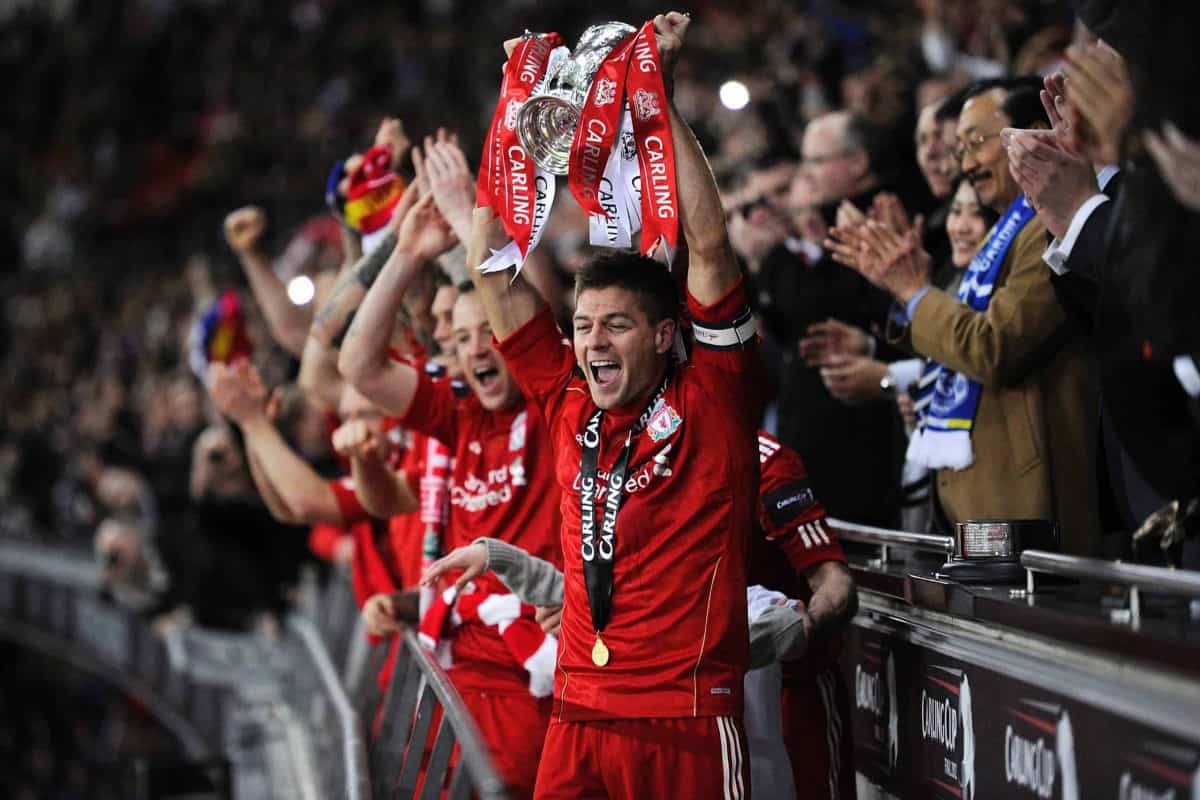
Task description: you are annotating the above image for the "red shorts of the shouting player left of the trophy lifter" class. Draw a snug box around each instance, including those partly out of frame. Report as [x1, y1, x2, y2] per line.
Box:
[458, 690, 553, 800]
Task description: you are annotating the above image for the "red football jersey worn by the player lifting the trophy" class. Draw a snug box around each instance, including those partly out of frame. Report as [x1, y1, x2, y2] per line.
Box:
[499, 283, 763, 721]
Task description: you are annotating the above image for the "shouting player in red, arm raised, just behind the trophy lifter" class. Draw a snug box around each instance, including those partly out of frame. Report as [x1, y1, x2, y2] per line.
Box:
[338, 181, 562, 796]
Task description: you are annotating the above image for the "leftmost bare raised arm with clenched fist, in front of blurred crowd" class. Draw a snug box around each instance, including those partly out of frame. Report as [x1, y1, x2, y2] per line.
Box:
[224, 205, 312, 357]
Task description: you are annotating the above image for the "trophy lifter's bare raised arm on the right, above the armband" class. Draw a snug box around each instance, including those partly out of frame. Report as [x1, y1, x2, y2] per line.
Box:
[654, 11, 740, 306]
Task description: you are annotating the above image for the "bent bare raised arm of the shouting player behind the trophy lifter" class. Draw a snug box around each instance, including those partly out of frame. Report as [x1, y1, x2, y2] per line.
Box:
[337, 187, 455, 416]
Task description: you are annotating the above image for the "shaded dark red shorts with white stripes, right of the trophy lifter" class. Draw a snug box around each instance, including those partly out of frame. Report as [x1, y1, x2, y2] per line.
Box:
[782, 667, 856, 800]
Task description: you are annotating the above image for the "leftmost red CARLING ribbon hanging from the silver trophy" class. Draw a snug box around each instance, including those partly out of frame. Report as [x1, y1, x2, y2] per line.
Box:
[475, 34, 563, 253]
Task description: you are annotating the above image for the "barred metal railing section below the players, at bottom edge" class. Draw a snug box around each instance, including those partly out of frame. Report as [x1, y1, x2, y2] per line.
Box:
[371, 630, 508, 800]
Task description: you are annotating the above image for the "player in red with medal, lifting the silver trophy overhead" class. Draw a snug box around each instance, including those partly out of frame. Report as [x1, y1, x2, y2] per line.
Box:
[417, 13, 762, 798]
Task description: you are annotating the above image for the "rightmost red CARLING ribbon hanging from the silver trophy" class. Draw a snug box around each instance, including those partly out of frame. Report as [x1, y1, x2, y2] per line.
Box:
[625, 22, 679, 254]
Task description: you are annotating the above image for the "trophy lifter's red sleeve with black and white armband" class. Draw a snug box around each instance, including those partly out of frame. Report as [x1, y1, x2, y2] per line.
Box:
[688, 278, 768, 427]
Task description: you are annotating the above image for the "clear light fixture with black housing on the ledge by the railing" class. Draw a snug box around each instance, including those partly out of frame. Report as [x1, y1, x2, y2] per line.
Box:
[935, 519, 1058, 584]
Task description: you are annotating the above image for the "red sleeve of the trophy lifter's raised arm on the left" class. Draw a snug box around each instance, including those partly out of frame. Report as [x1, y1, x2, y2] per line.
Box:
[493, 306, 575, 420]
